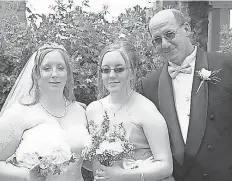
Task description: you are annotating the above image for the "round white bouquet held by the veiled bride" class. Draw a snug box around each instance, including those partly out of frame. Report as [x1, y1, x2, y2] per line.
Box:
[7, 124, 74, 177]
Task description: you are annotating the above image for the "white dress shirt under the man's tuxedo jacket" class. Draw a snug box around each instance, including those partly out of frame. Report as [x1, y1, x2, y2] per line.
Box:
[169, 46, 197, 143]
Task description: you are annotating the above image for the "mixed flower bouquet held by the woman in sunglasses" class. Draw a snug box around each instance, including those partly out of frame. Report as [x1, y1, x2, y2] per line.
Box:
[81, 111, 134, 166]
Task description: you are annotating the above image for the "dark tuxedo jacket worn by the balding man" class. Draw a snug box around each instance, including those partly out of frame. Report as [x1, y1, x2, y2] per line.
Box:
[140, 48, 232, 181]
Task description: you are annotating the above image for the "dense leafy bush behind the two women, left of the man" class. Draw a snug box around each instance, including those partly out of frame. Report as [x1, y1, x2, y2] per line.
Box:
[0, 1, 161, 109]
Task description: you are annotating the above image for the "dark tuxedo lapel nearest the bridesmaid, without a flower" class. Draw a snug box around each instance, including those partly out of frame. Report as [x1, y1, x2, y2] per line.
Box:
[158, 64, 184, 164]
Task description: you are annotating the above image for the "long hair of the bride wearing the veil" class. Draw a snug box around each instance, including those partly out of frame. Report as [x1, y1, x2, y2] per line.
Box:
[20, 43, 75, 105]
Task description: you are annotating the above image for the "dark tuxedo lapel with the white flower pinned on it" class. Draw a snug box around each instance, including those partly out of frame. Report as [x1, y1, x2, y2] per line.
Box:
[184, 49, 208, 170]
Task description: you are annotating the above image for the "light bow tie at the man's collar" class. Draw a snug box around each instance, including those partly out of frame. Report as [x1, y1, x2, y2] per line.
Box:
[168, 64, 192, 79]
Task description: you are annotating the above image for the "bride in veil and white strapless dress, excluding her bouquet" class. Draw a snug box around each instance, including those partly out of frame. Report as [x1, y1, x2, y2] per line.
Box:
[0, 43, 88, 181]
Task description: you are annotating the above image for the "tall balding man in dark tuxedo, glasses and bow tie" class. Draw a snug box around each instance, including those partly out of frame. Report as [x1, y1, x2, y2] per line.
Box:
[140, 9, 232, 181]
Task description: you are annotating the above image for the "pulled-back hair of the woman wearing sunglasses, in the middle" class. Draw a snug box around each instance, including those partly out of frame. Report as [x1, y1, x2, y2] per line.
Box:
[97, 41, 139, 99]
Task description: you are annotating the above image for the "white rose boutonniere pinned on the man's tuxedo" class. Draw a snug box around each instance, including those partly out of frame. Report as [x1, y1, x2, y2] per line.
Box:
[196, 68, 222, 94]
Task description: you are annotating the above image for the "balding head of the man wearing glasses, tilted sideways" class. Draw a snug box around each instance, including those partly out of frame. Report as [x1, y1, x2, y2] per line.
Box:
[149, 9, 194, 65]
